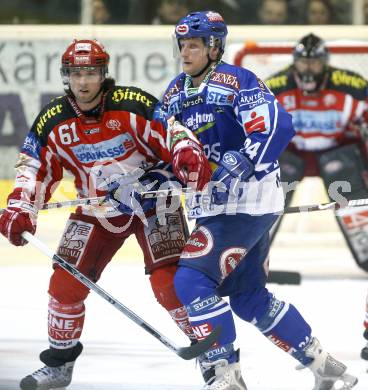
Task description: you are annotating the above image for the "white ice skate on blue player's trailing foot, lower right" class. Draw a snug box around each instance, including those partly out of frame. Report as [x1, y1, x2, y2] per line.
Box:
[305, 338, 358, 390]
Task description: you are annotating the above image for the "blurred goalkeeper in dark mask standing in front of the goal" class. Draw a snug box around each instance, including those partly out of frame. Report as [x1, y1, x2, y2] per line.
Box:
[266, 34, 368, 366]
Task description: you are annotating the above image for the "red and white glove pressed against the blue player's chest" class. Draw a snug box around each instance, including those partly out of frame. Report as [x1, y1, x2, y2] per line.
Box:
[169, 121, 212, 190]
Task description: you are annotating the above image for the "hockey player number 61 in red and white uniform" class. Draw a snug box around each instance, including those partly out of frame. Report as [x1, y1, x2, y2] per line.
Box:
[0, 40, 211, 390]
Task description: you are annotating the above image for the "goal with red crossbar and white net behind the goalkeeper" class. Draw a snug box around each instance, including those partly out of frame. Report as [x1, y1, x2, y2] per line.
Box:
[233, 41, 368, 278]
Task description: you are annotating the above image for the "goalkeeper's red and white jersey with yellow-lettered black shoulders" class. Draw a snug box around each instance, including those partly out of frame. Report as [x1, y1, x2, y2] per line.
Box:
[266, 66, 368, 151]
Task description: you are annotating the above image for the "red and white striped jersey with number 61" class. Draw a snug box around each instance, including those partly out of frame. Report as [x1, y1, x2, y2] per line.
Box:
[15, 86, 170, 216]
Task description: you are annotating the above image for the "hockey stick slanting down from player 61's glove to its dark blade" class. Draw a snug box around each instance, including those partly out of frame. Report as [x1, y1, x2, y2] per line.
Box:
[22, 232, 221, 360]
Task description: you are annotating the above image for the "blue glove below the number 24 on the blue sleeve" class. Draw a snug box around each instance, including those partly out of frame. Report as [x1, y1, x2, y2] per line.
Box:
[211, 150, 254, 204]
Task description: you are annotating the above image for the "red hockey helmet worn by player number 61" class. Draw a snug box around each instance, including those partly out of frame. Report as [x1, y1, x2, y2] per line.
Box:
[60, 39, 110, 84]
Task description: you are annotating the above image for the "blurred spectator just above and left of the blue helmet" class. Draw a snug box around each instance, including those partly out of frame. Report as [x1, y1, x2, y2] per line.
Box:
[151, 0, 193, 25]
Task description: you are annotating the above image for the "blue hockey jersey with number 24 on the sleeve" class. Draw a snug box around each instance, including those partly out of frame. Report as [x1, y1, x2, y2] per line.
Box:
[162, 62, 294, 216]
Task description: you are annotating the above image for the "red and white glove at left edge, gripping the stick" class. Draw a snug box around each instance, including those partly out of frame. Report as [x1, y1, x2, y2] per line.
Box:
[0, 189, 37, 246]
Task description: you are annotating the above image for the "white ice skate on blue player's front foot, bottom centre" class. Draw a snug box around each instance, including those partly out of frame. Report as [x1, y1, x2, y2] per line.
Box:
[199, 351, 247, 390]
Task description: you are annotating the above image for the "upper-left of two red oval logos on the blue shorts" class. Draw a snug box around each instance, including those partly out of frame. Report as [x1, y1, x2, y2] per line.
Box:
[181, 226, 213, 259]
